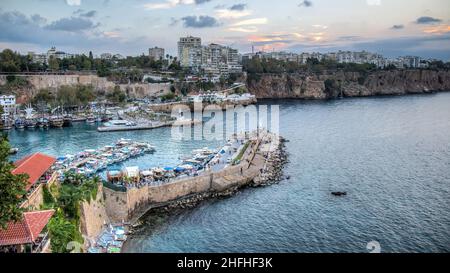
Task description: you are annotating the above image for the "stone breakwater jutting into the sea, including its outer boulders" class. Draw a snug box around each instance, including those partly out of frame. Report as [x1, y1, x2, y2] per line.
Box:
[82, 133, 286, 241]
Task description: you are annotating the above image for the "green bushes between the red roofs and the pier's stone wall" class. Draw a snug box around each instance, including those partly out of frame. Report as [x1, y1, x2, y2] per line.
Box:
[44, 173, 100, 253]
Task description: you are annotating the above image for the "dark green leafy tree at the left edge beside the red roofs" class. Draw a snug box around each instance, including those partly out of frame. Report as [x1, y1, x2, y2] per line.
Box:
[0, 136, 28, 228]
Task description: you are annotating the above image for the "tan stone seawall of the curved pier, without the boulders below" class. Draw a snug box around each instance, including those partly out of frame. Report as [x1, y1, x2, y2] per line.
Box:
[98, 131, 278, 223]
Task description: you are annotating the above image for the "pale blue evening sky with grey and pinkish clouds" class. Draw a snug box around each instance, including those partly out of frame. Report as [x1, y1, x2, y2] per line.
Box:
[0, 0, 450, 61]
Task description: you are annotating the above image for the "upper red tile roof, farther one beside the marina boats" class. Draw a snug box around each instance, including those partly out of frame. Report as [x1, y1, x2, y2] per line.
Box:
[12, 153, 56, 191]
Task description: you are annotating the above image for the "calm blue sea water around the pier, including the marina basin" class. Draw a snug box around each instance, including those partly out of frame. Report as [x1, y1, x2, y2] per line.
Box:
[10, 93, 450, 252]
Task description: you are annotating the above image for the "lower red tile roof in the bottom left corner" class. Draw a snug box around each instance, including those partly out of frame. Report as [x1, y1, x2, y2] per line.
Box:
[0, 210, 55, 246]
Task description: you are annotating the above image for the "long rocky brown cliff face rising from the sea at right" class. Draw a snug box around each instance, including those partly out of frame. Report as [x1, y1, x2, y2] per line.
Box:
[247, 70, 450, 99]
